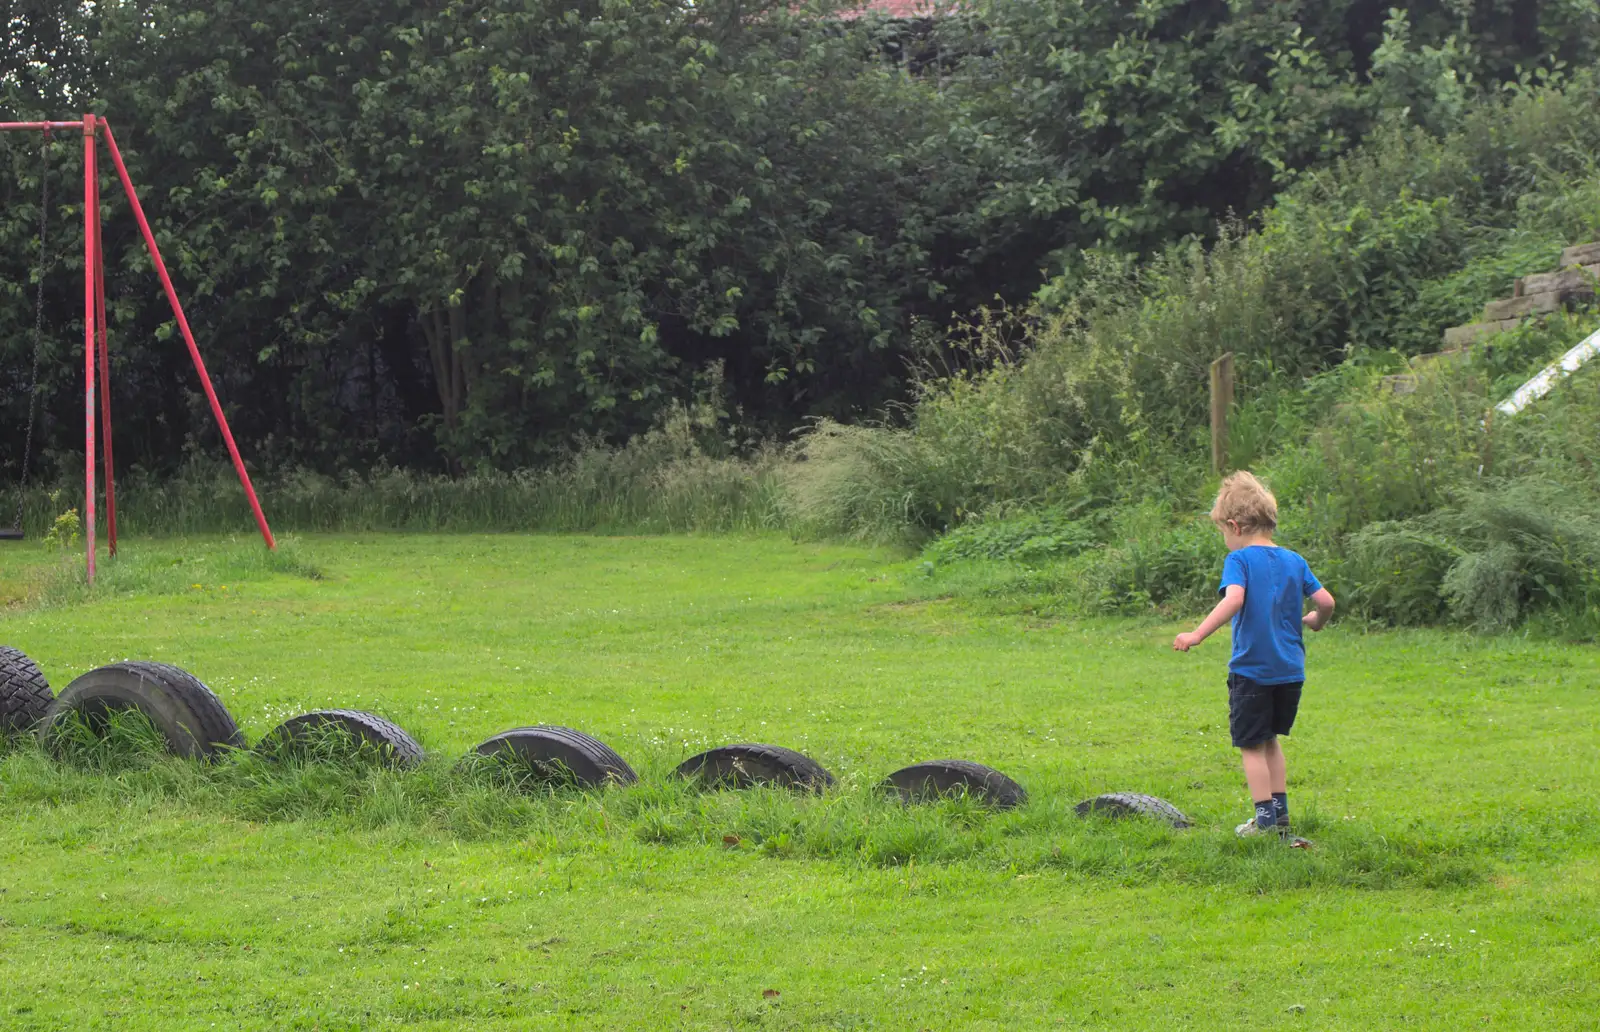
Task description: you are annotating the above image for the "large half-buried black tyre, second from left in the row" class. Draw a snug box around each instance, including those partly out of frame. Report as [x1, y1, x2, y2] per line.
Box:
[38, 662, 243, 760]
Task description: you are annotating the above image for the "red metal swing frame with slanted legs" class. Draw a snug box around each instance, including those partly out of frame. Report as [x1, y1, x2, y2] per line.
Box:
[0, 115, 278, 584]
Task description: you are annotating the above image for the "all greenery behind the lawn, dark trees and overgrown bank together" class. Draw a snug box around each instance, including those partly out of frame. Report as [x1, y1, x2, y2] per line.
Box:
[0, 0, 1600, 635]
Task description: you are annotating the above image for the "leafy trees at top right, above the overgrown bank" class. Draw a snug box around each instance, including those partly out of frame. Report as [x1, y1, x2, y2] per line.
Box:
[939, 0, 1600, 262]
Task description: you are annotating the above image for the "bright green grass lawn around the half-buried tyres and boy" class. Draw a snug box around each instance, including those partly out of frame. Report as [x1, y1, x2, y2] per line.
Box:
[0, 536, 1600, 1032]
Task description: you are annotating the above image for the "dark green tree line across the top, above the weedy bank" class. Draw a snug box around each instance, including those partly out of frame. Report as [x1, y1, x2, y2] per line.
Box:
[0, 0, 1597, 480]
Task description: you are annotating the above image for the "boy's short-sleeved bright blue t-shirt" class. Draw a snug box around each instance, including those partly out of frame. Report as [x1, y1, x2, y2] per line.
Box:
[1218, 544, 1322, 685]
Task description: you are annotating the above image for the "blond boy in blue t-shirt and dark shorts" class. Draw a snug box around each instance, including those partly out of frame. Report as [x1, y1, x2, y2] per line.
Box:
[1173, 472, 1333, 850]
